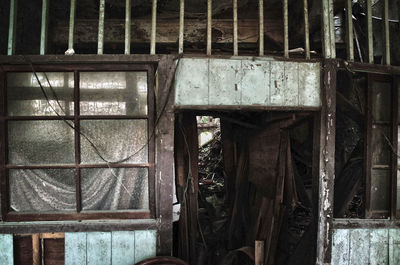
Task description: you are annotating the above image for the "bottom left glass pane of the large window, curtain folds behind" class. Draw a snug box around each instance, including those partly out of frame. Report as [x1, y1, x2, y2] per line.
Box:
[9, 169, 76, 212]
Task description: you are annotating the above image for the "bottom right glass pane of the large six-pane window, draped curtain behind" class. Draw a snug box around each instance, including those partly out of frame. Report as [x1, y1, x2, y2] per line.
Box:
[81, 168, 149, 210]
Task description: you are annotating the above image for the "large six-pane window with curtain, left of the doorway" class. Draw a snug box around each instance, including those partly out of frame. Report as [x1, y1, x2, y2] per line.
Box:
[0, 64, 155, 221]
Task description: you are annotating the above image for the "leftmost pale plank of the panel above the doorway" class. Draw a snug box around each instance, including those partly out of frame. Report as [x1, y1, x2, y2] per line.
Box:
[175, 58, 209, 105]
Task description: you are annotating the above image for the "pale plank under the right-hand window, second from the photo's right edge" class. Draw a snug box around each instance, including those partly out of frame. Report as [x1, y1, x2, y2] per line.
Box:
[369, 229, 389, 265]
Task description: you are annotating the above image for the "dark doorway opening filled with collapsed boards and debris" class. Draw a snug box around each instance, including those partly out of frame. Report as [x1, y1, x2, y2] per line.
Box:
[175, 111, 316, 265]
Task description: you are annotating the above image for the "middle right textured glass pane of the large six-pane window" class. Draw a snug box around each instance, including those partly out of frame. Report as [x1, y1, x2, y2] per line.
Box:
[81, 120, 148, 163]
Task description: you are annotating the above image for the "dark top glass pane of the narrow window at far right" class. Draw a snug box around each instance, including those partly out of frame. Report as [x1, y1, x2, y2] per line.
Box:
[372, 82, 392, 121]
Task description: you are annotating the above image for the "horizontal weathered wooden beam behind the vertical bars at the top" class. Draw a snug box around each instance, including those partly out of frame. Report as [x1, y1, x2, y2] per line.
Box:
[49, 17, 283, 45]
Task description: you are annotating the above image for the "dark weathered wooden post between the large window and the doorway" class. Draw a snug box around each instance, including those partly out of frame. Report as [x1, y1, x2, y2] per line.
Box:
[155, 55, 176, 256]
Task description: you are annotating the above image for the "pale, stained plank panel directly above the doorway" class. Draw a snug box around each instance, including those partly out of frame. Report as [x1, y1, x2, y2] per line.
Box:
[175, 58, 321, 107]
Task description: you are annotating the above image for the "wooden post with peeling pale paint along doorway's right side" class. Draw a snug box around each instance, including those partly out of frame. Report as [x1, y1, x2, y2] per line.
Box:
[317, 59, 336, 265]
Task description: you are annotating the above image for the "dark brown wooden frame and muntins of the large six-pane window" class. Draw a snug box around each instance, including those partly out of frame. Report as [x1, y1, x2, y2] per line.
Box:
[0, 63, 156, 222]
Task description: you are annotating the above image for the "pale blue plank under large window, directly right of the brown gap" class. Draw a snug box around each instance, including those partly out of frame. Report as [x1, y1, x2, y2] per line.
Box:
[65, 233, 86, 265]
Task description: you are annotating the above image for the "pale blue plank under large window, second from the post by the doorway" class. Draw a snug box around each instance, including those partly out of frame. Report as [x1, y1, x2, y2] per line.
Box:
[111, 231, 135, 265]
